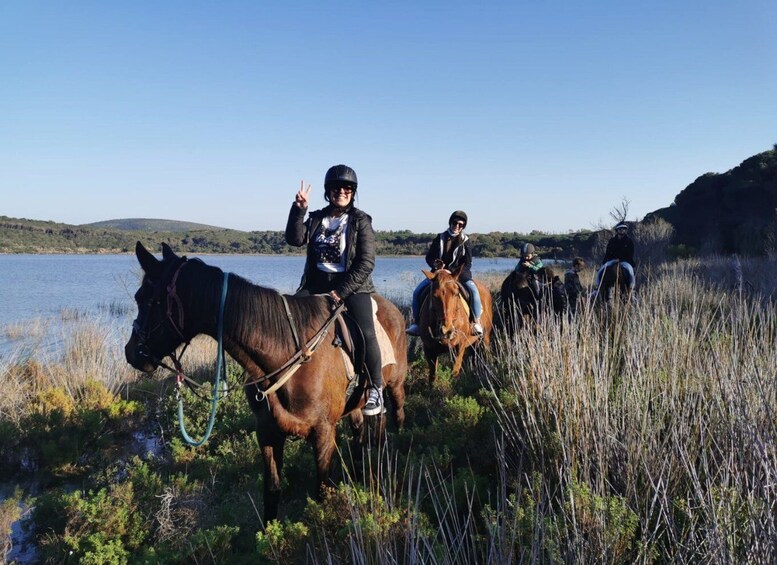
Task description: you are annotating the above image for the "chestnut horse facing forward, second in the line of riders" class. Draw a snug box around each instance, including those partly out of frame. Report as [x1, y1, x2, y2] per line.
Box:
[419, 269, 493, 382]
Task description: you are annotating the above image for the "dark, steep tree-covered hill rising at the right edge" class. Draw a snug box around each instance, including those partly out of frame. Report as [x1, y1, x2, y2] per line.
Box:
[645, 145, 777, 255]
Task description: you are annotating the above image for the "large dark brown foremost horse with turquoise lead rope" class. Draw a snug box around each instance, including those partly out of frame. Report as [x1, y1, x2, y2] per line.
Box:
[125, 242, 407, 520]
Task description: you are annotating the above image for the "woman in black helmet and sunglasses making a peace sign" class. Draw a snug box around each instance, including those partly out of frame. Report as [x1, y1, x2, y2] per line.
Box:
[286, 165, 383, 416]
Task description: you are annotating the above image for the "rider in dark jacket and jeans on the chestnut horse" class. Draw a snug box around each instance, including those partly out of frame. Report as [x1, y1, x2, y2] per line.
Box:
[406, 210, 483, 336]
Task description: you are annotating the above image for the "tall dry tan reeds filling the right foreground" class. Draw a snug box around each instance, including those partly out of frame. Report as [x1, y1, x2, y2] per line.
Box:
[489, 262, 777, 562]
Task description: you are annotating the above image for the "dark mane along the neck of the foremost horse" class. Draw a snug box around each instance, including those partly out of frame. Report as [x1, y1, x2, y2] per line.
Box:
[186, 264, 329, 353]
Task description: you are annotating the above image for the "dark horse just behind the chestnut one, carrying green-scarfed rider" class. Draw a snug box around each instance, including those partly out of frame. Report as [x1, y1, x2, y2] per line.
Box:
[499, 267, 567, 332]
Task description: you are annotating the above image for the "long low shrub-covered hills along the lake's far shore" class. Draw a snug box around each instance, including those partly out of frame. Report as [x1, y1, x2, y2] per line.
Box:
[0, 216, 593, 259]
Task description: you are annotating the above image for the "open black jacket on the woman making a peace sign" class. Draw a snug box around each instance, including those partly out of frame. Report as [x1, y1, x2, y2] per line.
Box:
[286, 204, 375, 299]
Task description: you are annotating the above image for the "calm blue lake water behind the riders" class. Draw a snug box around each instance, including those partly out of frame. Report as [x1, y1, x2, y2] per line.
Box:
[0, 255, 516, 355]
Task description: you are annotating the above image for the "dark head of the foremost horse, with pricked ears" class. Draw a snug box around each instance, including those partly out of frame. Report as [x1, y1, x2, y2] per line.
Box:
[124, 242, 192, 372]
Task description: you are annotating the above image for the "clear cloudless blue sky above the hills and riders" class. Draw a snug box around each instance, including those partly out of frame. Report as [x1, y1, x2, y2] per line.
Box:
[0, 0, 777, 232]
